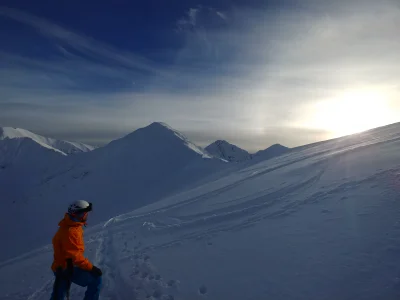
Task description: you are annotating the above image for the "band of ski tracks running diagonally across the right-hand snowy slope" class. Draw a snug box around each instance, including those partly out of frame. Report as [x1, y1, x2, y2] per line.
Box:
[108, 165, 400, 258]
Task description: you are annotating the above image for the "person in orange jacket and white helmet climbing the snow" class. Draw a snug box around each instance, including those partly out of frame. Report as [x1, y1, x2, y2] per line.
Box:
[50, 200, 102, 300]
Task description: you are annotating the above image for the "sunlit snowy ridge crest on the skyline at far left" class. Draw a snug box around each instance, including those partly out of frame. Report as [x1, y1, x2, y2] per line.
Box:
[0, 127, 94, 155]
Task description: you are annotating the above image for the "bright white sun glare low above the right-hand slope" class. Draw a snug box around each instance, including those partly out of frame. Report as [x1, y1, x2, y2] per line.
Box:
[312, 89, 390, 137]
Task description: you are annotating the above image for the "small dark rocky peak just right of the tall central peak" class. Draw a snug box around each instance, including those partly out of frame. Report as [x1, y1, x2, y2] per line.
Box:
[205, 140, 251, 162]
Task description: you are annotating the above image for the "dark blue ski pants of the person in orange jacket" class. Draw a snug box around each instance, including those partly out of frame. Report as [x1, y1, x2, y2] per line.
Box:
[50, 267, 102, 300]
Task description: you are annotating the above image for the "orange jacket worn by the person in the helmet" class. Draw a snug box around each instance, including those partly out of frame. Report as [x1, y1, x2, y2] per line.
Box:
[51, 214, 93, 272]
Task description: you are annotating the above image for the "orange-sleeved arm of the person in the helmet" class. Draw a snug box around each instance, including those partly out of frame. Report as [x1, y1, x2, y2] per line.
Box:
[64, 228, 93, 271]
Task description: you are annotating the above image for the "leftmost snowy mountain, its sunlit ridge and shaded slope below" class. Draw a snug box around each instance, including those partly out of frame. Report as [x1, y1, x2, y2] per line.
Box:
[0, 127, 93, 213]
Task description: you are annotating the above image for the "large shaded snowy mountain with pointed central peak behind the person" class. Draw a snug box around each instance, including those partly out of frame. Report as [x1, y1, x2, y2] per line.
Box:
[0, 123, 226, 257]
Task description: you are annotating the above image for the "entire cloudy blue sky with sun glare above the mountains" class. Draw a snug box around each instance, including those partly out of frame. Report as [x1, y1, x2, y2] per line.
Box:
[0, 0, 400, 151]
